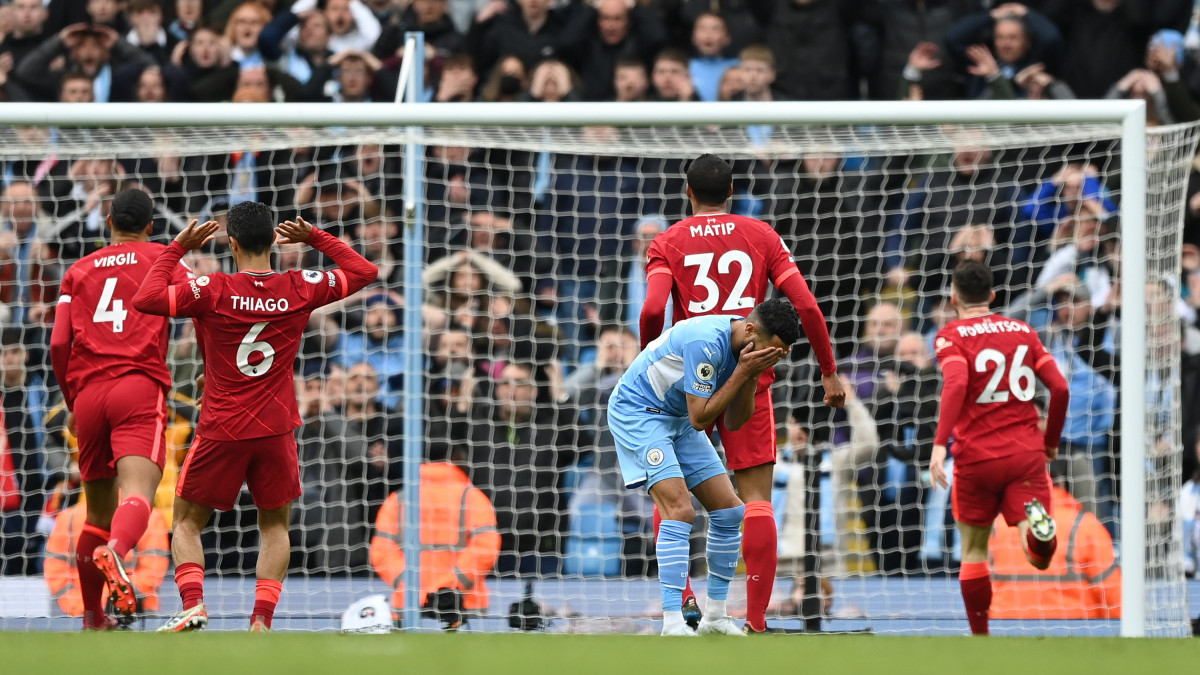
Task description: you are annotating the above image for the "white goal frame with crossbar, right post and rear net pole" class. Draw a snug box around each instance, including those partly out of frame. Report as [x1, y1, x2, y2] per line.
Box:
[0, 101, 1183, 637]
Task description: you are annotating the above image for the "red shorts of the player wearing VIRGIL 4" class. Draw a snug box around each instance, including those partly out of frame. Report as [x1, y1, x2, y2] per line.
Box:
[74, 372, 167, 483]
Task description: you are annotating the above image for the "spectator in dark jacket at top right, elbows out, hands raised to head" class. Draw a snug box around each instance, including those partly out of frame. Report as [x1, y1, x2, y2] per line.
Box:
[946, 2, 1062, 98]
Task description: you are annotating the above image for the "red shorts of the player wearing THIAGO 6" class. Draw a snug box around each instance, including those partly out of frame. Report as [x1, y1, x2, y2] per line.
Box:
[175, 431, 300, 510]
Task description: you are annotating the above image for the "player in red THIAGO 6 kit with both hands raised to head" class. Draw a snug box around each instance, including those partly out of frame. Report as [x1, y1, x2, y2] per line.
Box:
[133, 202, 378, 632]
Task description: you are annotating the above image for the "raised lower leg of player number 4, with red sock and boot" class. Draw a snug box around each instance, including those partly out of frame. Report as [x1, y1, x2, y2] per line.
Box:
[91, 455, 162, 616]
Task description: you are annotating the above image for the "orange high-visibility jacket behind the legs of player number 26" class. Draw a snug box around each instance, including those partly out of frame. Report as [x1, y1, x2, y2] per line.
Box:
[988, 488, 1121, 619]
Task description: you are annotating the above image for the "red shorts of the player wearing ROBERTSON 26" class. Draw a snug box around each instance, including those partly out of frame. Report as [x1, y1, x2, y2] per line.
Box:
[950, 453, 1052, 527]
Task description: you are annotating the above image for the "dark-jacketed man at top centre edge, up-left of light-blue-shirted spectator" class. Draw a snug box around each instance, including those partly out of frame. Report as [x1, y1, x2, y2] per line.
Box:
[578, 0, 666, 101]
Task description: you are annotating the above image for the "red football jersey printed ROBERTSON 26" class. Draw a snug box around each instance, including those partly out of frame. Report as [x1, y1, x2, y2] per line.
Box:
[934, 313, 1061, 462]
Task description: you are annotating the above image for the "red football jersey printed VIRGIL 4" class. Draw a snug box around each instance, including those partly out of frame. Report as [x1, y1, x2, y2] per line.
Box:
[54, 241, 192, 402]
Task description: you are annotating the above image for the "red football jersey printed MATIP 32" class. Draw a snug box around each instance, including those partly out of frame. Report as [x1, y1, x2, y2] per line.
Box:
[646, 214, 799, 321]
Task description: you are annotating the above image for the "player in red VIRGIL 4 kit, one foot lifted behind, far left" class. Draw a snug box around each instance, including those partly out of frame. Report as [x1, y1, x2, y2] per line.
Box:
[50, 190, 191, 629]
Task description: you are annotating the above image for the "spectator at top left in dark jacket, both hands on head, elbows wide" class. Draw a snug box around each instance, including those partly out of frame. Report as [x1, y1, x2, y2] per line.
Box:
[14, 24, 154, 103]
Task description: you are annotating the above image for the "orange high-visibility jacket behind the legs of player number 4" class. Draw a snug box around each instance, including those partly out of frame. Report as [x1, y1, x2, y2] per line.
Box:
[43, 500, 170, 616]
